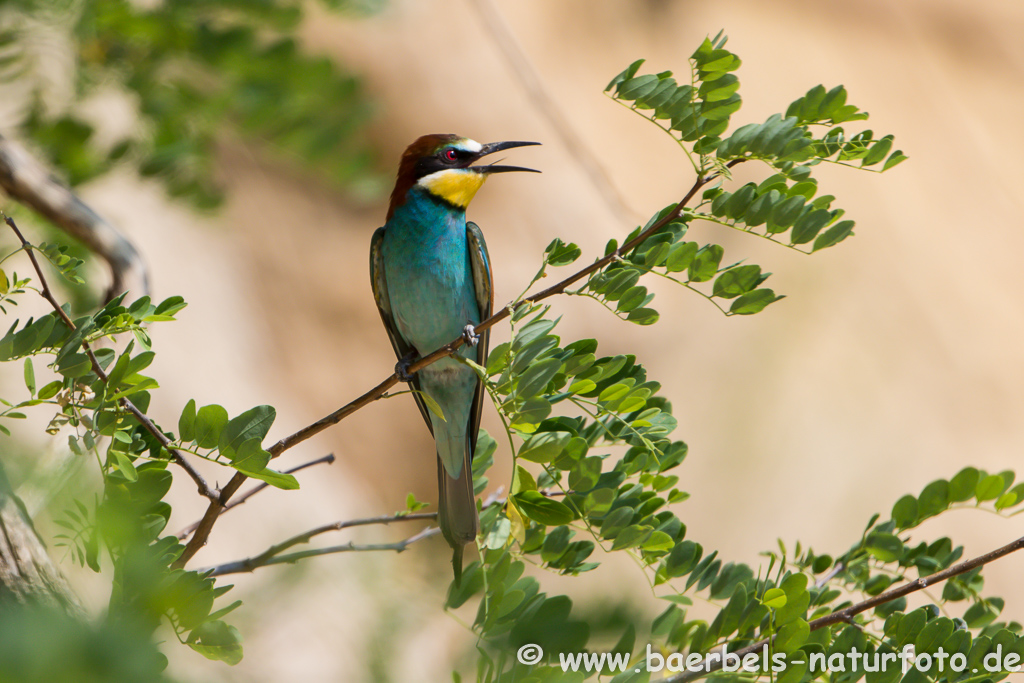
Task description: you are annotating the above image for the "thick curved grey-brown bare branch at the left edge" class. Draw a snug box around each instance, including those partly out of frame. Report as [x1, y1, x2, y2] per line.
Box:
[0, 135, 148, 301]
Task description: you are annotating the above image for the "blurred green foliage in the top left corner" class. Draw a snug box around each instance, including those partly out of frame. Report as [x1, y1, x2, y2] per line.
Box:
[0, 0, 380, 208]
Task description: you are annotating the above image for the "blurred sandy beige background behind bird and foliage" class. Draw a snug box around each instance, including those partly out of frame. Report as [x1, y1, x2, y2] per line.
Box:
[9, 0, 1024, 683]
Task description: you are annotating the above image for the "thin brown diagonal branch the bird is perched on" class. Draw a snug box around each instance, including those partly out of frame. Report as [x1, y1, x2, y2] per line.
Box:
[174, 159, 743, 567]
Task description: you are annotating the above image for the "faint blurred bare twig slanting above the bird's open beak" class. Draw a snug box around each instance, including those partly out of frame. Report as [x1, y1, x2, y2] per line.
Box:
[470, 0, 636, 224]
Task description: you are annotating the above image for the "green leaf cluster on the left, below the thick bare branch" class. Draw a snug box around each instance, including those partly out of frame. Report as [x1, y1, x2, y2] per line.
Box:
[0, 255, 298, 664]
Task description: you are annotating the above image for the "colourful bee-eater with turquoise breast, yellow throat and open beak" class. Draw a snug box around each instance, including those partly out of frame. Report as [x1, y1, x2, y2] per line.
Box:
[370, 134, 540, 585]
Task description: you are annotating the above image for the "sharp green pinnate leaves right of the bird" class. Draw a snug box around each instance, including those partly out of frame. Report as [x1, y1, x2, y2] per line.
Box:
[436, 39, 1024, 683]
